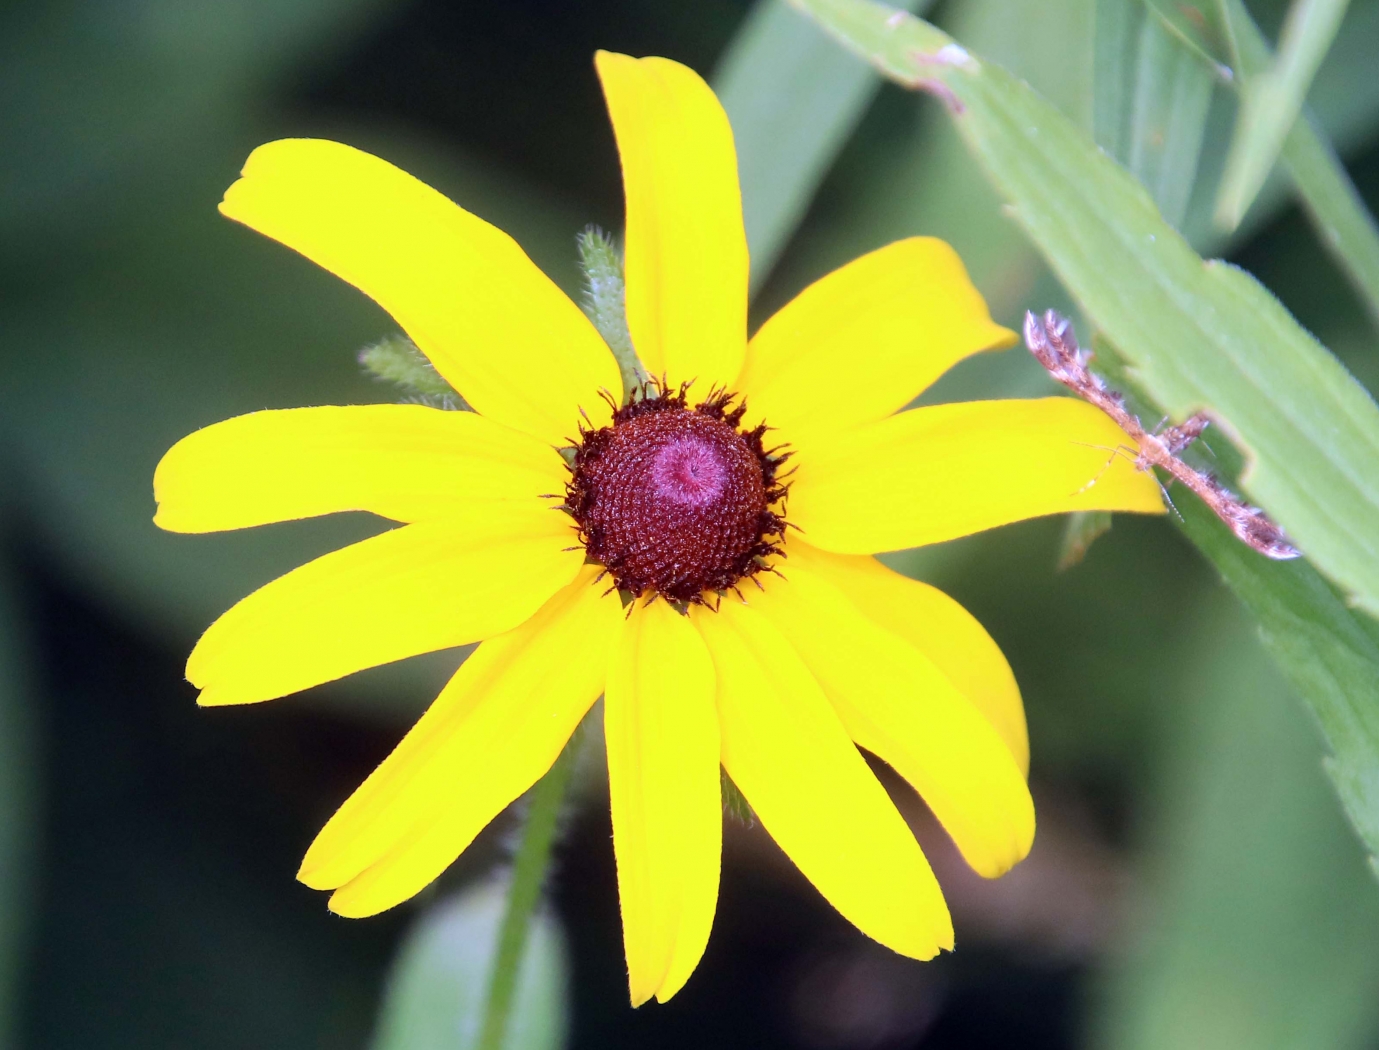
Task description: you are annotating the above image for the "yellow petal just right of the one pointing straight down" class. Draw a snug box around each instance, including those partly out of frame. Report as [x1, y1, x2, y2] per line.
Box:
[691, 599, 953, 959]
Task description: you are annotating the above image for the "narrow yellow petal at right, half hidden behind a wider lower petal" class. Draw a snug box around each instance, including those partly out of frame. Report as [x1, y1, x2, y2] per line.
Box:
[781, 538, 1030, 774]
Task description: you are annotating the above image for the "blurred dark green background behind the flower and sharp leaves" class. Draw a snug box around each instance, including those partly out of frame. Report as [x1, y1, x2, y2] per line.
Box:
[0, 0, 1379, 1050]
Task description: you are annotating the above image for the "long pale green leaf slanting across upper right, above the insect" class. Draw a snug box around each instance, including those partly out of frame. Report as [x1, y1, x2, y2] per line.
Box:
[796, 0, 1379, 613]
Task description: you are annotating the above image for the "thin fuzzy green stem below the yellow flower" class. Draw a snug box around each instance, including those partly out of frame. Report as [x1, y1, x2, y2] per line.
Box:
[479, 731, 579, 1050]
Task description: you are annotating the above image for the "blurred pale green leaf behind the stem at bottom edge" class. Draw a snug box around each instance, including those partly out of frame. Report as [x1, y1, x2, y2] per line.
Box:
[372, 879, 570, 1050]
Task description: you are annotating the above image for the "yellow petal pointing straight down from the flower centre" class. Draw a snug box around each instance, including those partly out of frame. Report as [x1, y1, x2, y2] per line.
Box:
[604, 600, 723, 1006]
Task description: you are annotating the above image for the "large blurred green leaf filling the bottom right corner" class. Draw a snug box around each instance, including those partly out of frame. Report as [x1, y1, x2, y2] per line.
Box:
[1089, 598, 1379, 1050]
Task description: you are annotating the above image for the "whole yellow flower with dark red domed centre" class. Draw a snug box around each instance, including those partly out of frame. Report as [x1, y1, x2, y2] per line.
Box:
[154, 52, 1162, 1003]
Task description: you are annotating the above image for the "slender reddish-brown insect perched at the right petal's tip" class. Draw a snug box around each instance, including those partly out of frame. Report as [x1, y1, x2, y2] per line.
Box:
[1025, 310, 1302, 562]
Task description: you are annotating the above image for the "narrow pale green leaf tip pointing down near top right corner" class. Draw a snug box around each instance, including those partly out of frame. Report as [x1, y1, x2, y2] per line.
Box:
[1216, 0, 1350, 229]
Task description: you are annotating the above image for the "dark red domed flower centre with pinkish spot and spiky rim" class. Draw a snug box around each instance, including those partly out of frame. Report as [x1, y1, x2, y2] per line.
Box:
[565, 386, 789, 603]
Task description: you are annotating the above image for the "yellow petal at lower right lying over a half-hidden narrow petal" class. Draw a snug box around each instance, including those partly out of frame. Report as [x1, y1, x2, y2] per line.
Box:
[749, 545, 1034, 879]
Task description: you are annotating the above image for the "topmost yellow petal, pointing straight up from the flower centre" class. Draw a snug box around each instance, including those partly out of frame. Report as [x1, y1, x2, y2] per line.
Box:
[596, 51, 747, 395]
